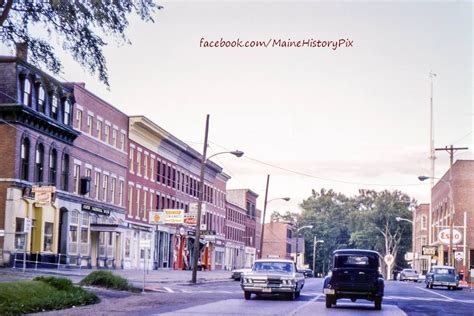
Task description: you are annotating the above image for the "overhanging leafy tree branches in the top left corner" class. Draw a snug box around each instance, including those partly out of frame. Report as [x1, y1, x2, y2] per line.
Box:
[0, 0, 162, 86]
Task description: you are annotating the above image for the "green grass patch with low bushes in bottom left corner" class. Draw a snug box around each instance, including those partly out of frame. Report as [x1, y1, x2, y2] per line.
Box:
[0, 277, 100, 315]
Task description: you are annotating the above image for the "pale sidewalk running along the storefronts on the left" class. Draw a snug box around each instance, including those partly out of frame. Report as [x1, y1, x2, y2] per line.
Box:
[0, 268, 233, 289]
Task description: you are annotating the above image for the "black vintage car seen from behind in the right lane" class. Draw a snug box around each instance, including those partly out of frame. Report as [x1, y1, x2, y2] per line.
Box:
[324, 249, 384, 310]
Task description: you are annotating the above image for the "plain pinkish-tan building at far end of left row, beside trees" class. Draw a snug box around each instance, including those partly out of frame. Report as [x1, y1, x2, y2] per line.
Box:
[262, 220, 292, 259]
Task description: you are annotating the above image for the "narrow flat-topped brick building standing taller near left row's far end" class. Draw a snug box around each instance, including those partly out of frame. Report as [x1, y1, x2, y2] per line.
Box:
[227, 189, 260, 267]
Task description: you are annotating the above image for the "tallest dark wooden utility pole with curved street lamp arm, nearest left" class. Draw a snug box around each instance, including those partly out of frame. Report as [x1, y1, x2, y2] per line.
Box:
[191, 114, 244, 283]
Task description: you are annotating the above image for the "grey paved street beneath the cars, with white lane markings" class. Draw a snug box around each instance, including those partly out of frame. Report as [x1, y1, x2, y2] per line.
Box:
[27, 278, 474, 315]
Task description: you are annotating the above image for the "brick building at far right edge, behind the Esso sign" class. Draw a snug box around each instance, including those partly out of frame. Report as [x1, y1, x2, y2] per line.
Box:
[431, 160, 474, 271]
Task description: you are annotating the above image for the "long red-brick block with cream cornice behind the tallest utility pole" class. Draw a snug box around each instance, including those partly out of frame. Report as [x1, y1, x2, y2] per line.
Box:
[127, 116, 230, 269]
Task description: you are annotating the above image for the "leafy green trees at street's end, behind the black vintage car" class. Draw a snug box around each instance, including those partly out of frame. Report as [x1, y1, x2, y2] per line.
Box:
[297, 189, 415, 272]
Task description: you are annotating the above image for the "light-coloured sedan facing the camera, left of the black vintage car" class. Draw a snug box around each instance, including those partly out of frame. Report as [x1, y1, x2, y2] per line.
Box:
[240, 259, 304, 300]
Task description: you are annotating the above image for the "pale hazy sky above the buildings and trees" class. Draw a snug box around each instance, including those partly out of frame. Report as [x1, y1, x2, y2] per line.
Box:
[0, 1, 474, 221]
